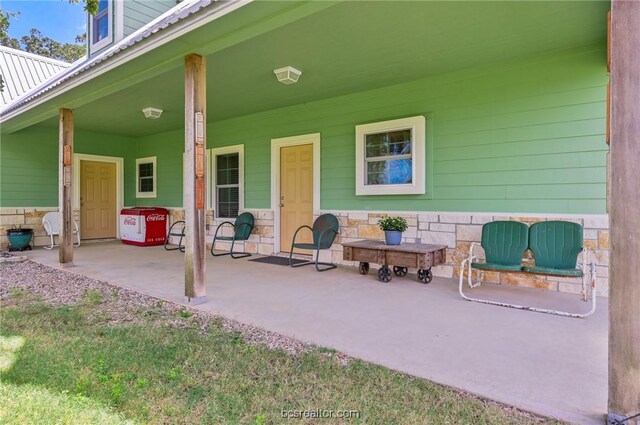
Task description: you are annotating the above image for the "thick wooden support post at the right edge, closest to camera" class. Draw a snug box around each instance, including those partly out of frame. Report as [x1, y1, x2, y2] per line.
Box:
[608, 0, 640, 425]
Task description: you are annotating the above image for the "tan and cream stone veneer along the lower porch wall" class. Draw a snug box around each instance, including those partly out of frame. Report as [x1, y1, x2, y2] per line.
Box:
[0, 208, 609, 296]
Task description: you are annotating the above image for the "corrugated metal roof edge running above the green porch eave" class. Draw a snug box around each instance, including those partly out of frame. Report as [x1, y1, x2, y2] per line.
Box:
[0, 0, 225, 116]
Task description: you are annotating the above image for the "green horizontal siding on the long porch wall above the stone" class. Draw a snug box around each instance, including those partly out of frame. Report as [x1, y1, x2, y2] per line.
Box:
[139, 47, 608, 213]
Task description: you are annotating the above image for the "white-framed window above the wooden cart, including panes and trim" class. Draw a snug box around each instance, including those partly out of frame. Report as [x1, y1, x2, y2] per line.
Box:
[356, 115, 425, 195]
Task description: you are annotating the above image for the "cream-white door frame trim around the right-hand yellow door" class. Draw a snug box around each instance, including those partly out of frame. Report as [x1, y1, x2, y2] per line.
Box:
[271, 133, 320, 253]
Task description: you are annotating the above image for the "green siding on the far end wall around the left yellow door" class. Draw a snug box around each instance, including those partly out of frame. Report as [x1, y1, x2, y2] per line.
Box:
[0, 127, 135, 207]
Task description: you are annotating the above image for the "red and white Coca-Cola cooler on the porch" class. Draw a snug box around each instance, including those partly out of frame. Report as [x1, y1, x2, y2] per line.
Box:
[120, 207, 169, 246]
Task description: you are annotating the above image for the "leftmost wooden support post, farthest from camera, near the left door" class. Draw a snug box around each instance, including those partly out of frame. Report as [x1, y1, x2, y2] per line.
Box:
[58, 108, 73, 267]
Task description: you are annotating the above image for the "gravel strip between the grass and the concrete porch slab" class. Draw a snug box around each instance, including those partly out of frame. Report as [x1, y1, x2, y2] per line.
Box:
[0, 261, 349, 365]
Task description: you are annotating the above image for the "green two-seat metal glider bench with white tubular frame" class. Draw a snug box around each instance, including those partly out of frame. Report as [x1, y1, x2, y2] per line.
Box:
[458, 221, 596, 318]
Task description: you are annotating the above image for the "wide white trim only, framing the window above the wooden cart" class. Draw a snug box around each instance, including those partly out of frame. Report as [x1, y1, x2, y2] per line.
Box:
[355, 115, 426, 196]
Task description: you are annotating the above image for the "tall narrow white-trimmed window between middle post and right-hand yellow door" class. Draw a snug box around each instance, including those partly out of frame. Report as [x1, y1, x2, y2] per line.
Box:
[211, 145, 244, 218]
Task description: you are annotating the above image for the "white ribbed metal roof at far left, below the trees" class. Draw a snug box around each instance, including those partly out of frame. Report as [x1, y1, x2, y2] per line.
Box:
[0, 46, 71, 109]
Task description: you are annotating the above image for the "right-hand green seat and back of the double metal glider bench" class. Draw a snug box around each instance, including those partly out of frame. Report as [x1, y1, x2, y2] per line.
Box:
[522, 221, 583, 277]
